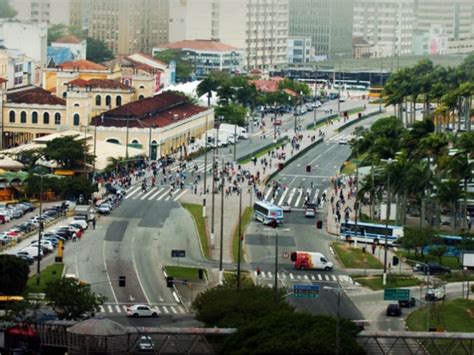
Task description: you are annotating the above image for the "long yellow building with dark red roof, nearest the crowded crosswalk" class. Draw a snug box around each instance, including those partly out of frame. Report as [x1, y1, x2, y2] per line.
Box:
[92, 92, 214, 159]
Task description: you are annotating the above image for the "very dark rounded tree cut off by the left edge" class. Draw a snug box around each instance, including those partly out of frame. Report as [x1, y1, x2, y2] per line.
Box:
[0, 254, 30, 296]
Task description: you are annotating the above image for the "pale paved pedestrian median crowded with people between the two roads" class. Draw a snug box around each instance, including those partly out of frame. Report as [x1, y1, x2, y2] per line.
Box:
[181, 110, 382, 262]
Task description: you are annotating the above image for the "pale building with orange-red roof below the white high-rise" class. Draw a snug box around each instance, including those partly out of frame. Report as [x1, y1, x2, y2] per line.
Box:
[153, 40, 244, 77]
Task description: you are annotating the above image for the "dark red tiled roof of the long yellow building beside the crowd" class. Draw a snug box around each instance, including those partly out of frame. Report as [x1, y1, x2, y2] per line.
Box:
[92, 92, 207, 128]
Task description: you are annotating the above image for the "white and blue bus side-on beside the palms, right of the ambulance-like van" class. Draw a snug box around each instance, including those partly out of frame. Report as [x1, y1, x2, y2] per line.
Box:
[340, 221, 403, 245]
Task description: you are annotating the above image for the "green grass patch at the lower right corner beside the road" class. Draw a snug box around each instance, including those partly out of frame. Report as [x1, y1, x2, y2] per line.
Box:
[407, 299, 474, 332]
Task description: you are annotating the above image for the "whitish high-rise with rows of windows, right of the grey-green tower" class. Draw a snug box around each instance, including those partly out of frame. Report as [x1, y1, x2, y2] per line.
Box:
[353, 0, 415, 57]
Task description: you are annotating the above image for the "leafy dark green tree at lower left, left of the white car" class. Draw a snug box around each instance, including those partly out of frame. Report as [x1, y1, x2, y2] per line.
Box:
[45, 278, 105, 320]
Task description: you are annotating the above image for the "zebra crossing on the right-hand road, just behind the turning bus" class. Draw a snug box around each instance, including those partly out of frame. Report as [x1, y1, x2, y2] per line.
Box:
[263, 186, 326, 209]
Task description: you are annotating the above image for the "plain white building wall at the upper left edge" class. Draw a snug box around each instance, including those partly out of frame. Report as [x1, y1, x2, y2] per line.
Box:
[0, 20, 48, 65]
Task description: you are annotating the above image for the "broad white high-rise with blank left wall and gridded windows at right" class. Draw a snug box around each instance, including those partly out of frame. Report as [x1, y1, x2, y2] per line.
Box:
[170, 0, 288, 70]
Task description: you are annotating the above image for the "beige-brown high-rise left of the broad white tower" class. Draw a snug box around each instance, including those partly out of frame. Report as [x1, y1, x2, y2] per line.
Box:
[89, 0, 169, 54]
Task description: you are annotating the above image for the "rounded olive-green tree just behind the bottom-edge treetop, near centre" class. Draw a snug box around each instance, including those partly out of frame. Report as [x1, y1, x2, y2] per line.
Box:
[192, 283, 293, 328]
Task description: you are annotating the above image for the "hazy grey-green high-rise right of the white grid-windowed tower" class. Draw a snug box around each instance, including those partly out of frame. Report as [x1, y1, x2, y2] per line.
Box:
[289, 0, 353, 59]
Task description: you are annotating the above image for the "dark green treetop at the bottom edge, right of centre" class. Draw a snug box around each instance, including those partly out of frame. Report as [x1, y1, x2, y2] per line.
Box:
[223, 311, 365, 355]
